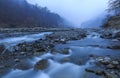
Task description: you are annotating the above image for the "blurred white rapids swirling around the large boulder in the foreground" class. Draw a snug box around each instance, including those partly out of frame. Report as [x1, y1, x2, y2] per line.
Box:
[2, 50, 90, 78]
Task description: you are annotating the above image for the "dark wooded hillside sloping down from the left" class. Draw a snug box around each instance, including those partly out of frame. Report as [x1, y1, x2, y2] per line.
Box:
[0, 0, 64, 28]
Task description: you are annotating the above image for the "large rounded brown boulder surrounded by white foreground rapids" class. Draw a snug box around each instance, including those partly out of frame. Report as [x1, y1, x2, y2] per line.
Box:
[34, 59, 49, 71]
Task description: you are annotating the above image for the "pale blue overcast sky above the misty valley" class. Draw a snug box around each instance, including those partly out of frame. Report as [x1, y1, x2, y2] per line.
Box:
[27, 0, 108, 26]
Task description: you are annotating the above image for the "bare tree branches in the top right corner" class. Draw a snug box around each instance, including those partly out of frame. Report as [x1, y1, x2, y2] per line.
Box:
[109, 0, 120, 15]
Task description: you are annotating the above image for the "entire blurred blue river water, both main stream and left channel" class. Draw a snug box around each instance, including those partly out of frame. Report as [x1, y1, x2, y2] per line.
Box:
[0, 28, 120, 78]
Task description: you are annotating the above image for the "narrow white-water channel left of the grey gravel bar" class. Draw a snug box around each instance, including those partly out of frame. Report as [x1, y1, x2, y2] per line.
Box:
[0, 32, 51, 45]
